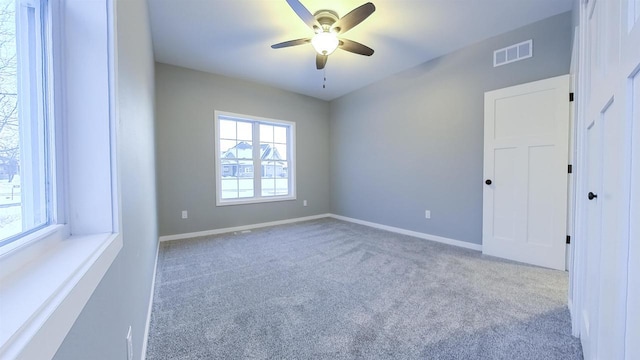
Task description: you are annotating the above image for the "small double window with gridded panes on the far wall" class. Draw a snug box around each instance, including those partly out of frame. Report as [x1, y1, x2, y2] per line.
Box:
[215, 111, 296, 206]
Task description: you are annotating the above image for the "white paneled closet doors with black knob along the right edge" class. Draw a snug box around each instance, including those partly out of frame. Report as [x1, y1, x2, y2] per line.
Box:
[571, 0, 640, 359]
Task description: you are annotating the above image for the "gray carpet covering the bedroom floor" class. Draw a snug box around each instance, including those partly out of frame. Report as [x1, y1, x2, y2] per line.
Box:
[147, 219, 582, 360]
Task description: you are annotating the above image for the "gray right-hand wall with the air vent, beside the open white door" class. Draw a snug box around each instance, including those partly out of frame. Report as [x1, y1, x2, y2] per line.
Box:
[330, 12, 572, 244]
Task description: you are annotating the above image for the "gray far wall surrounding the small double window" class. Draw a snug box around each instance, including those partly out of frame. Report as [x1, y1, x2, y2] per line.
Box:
[156, 64, 330, 235]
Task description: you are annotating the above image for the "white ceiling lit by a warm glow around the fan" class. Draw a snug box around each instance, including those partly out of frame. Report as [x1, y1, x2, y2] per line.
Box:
[149, 0, 573, 100]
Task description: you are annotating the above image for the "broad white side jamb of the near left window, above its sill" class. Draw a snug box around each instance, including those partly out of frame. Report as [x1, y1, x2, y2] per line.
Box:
[64, 0, 115, 234]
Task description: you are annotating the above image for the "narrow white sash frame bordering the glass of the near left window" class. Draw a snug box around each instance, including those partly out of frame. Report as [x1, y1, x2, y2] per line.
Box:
[0, 0, 55, 250]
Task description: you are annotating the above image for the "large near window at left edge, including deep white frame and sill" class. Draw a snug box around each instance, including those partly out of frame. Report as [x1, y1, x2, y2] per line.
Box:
[0, 0, 123, 359]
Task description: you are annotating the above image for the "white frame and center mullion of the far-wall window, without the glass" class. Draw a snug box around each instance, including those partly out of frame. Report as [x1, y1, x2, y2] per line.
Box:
[214, 110, 296, 206]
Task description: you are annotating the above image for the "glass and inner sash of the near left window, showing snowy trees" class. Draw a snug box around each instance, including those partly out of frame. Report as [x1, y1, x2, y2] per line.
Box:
[0, 0, 52, 246]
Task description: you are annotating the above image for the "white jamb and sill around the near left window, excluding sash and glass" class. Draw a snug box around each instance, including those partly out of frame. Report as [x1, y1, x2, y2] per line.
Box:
[0, 0, 123, 359]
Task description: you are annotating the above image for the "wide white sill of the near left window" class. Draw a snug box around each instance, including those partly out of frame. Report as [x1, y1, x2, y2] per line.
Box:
[0, 229, 122, 359]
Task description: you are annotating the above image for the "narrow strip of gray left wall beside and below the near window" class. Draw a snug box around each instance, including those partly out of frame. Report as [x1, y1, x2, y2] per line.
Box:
[55, 0, 158, 360]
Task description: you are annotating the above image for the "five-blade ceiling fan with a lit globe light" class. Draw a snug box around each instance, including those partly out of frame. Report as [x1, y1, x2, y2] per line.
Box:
[271, 0, 376, 70]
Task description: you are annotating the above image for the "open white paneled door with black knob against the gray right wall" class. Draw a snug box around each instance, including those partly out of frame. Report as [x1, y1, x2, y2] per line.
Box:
[482, 75, 570, 270]
